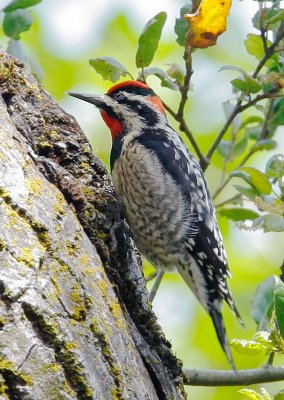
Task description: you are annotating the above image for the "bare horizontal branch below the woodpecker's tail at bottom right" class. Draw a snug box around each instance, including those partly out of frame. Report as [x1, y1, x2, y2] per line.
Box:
[183, 366, 284, 386]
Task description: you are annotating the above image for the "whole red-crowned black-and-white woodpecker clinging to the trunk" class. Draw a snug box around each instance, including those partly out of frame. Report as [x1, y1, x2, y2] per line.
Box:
[68, 81, 243, 368]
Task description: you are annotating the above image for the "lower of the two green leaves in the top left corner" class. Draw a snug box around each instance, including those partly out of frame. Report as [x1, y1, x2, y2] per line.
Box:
[3, 10, 33, 40]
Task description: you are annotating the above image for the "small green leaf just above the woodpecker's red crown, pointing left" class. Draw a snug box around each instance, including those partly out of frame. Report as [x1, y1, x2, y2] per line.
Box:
[89, 57, 129, 82]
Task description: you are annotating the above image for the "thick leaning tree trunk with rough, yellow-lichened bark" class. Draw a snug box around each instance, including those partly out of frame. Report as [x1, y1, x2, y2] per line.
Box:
[0, 51, 185, 400]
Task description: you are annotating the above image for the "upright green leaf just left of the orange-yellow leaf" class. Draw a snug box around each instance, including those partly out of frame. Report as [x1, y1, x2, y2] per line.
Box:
[136, 11, 167, 68]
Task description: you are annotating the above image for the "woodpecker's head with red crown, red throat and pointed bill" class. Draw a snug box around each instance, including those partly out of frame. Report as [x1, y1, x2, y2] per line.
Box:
[68, 81, 166, 140]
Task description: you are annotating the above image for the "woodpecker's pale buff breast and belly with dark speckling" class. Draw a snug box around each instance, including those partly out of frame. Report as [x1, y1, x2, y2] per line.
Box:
[112, 142, 195, 268]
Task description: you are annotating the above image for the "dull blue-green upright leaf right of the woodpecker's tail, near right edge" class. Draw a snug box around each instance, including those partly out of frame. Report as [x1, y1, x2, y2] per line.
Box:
[251, 275, 281, 330]
